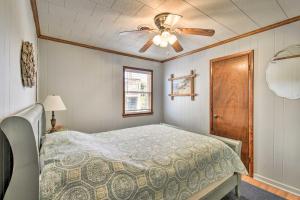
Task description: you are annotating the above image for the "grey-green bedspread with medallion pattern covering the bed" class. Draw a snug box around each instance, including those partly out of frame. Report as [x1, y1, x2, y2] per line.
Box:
[40, 125, 247, 200]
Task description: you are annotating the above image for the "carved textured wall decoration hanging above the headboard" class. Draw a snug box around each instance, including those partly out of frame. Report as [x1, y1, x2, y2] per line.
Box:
[21, 41, 37, 88]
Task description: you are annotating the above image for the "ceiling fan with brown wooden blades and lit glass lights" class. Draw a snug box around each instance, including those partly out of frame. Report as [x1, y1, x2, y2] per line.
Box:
[120, 13, 215, 53]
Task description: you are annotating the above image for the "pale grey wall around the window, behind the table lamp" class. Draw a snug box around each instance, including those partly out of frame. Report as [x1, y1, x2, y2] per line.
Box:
[38, 40, 163, 132]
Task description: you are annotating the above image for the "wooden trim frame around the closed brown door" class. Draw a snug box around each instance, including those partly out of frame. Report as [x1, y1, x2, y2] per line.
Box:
[209, 50, 254, 177]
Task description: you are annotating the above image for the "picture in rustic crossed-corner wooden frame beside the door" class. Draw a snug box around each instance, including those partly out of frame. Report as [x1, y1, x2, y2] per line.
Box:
[168, 70, 197, 100]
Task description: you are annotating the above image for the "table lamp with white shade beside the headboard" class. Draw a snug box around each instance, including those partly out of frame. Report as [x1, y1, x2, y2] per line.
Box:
[43, 95, 67, 133]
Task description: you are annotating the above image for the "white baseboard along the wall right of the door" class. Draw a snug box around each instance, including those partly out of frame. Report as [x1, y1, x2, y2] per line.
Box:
[253, 174, 300, 196]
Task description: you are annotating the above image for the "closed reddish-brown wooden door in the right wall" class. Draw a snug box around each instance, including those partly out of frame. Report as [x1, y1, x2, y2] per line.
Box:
[210, 51, 253, 176]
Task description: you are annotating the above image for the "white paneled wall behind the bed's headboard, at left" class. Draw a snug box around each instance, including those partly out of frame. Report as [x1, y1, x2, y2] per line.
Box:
[0, 0, 37, 199]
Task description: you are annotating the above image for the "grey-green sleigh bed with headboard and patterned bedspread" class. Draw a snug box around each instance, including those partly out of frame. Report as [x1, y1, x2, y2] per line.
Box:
[1, 104, 247, 200]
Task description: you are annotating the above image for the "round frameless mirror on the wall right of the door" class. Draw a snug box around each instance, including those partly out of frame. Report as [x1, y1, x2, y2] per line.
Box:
[266, 45, 300, 99]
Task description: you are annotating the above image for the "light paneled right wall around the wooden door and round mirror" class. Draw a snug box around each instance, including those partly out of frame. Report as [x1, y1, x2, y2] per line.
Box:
[163, 22, 300, 195]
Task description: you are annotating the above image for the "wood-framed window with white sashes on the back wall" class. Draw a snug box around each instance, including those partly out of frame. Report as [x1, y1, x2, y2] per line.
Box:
[123, 67, 153, 116]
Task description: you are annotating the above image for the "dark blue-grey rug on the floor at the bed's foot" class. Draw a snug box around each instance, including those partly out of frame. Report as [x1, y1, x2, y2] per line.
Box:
[222, 181, 284, 200]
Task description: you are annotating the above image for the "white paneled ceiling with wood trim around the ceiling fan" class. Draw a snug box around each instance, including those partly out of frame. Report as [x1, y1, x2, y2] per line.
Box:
[33, 0, 300, 60]
